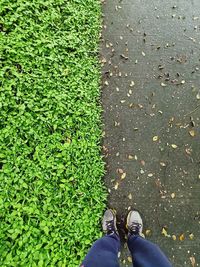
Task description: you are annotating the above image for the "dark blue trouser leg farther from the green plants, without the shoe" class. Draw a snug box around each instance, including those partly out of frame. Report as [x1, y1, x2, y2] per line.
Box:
[128, 236, 172, 267]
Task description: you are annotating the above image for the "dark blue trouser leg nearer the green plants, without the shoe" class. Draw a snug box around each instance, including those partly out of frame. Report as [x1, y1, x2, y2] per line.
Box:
[81, 234, 120, 267]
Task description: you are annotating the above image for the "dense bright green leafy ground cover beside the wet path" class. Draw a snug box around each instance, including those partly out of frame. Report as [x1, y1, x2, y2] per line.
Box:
[0, 0, 106, 267]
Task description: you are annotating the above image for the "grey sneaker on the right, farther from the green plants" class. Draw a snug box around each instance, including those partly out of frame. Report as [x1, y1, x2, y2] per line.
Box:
[126, 210, 143, 235]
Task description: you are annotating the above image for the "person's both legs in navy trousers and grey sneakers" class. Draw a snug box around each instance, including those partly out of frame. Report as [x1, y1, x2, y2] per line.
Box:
[81, 210, 172, 267]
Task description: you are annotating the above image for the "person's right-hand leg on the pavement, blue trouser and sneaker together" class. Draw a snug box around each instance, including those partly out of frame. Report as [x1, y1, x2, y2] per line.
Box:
[127, 211, 172, 267]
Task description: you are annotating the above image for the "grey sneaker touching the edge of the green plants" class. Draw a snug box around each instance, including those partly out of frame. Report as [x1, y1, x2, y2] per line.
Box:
[102, 209, 118, 235]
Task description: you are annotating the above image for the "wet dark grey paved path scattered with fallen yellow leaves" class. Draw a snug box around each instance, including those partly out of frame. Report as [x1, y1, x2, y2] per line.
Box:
[101, 0, 200, 267]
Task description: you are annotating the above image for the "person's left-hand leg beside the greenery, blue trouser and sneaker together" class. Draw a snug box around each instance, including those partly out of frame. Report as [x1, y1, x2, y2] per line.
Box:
[81, 209, 120, 267]
